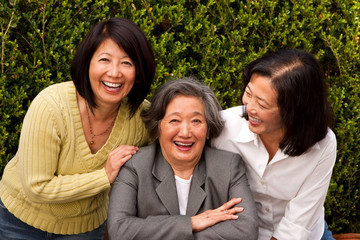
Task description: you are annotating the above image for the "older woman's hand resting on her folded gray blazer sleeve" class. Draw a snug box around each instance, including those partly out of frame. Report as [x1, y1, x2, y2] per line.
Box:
[191, 198, 244, 232]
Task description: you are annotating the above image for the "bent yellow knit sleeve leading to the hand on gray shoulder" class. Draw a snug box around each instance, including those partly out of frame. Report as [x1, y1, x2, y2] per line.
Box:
[17, 94, 110, 203]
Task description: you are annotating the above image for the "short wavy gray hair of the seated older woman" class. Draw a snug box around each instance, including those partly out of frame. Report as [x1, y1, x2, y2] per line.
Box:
[141, 77, 224, 139]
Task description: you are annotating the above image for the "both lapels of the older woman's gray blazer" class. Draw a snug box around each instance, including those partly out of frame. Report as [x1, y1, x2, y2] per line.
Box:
[152, 144, 206, 216]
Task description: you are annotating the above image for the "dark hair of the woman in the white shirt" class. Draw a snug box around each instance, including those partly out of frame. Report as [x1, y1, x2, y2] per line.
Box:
[243, 49, 332, 156]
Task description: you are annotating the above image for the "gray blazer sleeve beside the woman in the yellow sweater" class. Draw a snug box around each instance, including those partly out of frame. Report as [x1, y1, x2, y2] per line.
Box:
[107, 160, 193, 240]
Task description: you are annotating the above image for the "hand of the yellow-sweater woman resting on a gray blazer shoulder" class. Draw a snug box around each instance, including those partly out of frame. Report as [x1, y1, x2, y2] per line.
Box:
[105, 145, 139, 184]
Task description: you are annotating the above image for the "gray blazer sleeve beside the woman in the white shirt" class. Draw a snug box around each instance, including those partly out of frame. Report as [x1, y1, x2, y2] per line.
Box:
[194, 154, 258, 240]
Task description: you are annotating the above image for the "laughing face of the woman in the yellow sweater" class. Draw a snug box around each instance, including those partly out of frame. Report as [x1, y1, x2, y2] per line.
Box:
[89, 38, 136, 105]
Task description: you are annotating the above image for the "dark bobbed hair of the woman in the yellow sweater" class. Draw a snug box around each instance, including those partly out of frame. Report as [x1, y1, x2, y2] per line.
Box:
[71, 18, 156, 117]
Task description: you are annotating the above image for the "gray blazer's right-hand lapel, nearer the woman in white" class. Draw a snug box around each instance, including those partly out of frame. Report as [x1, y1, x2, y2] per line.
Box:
[186, 158, 206, 216]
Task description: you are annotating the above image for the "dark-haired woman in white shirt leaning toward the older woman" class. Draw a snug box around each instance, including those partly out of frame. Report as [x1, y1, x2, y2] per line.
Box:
[212, 49, 336, 240]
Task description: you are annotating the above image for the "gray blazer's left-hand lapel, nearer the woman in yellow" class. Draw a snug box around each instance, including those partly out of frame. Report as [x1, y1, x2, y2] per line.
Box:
[152, 146, 180, 215]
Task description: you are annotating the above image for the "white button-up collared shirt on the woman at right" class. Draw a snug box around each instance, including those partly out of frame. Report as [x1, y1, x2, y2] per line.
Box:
[212, 106, 336, 240]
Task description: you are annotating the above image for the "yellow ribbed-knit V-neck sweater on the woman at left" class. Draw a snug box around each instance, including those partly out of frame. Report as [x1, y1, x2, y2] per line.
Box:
[0, 82, 151, 234]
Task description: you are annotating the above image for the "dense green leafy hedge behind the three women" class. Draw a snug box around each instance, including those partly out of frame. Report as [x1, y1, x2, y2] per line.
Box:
[0, 0, 360, 233]
